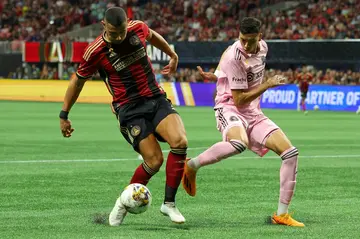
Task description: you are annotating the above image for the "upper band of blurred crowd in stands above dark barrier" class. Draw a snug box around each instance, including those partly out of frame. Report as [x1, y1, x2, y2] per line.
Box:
[0, 0, 360, 41]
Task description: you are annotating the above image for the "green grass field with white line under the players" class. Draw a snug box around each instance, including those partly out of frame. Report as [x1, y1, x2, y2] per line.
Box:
[0, 101, 360, 239]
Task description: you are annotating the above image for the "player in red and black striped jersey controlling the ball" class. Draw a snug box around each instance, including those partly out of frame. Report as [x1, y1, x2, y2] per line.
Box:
[60, 7, 187, 226]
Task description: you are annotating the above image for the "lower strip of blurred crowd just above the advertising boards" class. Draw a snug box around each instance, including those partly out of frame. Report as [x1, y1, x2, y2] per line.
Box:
[8, 63, 360, 85]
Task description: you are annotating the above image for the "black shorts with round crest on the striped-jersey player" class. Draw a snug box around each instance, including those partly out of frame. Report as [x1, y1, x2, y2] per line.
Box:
[114, 95, 177, 152]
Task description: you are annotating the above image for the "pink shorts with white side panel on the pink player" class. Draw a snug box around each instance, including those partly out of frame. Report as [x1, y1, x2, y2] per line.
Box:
[215, 106, 279, 157]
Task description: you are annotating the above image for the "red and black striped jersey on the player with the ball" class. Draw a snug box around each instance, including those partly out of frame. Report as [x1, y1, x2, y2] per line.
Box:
[76, 21, 164, 105]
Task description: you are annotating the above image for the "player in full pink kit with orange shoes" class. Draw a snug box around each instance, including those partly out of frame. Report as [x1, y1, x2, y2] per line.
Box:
[183, 17, 304, 227]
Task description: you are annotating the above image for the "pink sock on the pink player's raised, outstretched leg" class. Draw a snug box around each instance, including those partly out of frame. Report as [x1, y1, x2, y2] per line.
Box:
[188, 140, 246, 170]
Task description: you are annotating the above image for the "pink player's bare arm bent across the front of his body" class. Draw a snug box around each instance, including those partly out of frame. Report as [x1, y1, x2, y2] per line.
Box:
[231, 75, 286, 106]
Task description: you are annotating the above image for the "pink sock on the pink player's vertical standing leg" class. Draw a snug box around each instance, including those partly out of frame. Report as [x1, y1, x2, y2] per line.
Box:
[280, 147, 299, 205]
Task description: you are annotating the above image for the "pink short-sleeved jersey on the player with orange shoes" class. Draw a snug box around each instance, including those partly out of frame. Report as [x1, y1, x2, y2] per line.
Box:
[214, 40, 268, 116]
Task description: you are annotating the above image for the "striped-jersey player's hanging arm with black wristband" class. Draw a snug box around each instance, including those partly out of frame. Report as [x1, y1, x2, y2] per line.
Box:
[59, 76, 86, 138]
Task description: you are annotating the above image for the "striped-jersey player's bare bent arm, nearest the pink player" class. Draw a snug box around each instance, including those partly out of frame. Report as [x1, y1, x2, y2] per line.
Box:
[146, 29, 179, 75]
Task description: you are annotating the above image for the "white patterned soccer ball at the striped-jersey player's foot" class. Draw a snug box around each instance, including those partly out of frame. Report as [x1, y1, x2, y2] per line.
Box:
[120, 183, 152, 214]
